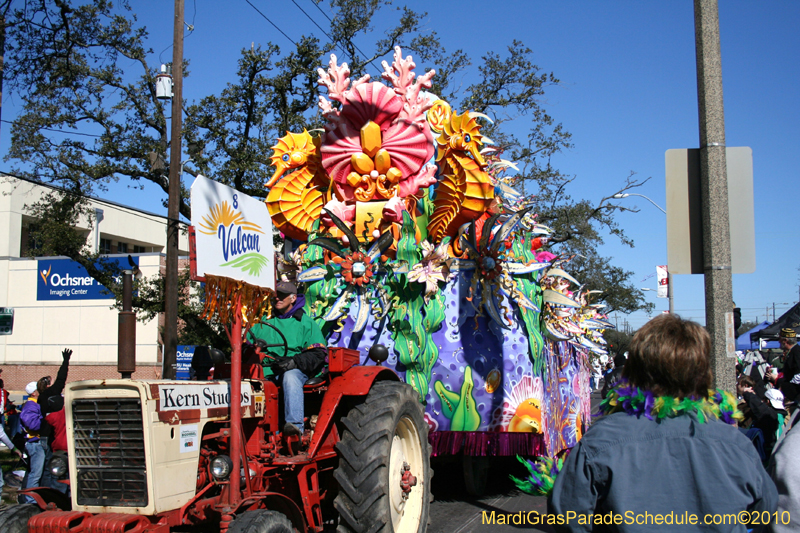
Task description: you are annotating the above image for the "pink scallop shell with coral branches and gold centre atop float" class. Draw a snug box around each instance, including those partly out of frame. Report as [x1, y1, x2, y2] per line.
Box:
[319, 48, 436, 218]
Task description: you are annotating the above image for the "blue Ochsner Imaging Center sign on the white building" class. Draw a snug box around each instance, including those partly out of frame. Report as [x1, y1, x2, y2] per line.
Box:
[36, 257, 139, 301]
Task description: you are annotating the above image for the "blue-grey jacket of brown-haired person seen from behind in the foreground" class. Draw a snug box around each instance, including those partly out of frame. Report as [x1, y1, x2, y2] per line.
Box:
[548, 412, 778, 533]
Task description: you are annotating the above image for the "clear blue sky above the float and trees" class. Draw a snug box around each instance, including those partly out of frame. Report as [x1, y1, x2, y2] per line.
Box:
[0, 0, 800, 328]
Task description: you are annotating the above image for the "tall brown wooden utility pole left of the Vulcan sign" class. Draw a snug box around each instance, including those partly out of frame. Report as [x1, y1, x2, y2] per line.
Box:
[161, 0, 184, 379]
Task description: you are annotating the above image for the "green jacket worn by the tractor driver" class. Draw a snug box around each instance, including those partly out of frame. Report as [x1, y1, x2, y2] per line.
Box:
[248, 300, 327, 377]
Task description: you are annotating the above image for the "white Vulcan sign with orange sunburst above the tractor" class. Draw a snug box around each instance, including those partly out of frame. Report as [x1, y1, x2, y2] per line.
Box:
[192, 176, 275, 287]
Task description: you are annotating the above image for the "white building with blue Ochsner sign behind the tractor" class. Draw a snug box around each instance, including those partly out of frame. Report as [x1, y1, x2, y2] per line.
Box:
[0, 176, 189, 390]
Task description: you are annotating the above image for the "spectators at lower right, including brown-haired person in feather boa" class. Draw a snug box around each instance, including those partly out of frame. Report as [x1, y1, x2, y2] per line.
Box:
[548, 315, 800, 532]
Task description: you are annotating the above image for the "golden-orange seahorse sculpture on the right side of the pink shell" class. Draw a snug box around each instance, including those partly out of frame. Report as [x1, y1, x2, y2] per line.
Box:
[428, 107, 494, 242]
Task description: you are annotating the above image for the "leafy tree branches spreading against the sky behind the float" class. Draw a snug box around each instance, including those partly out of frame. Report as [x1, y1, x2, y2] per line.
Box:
[6, 0, 648, 344]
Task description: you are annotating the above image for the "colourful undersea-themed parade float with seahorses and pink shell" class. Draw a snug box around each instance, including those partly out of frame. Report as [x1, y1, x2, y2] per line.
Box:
[266, 48, 611, 484]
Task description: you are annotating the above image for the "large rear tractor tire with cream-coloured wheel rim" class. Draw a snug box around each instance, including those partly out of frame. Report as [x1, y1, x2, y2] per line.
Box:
[333, 381, 431, 533]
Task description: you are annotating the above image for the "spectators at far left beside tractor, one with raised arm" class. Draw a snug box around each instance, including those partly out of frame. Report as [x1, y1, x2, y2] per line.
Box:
[0, 348, 72, 503]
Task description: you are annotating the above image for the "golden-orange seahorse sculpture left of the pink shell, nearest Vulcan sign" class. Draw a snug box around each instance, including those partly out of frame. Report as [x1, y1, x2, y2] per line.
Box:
[265, 130, 330, 240]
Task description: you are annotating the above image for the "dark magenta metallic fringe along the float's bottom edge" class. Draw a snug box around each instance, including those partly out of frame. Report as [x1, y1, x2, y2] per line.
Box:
[428, 431, 547, 457]
